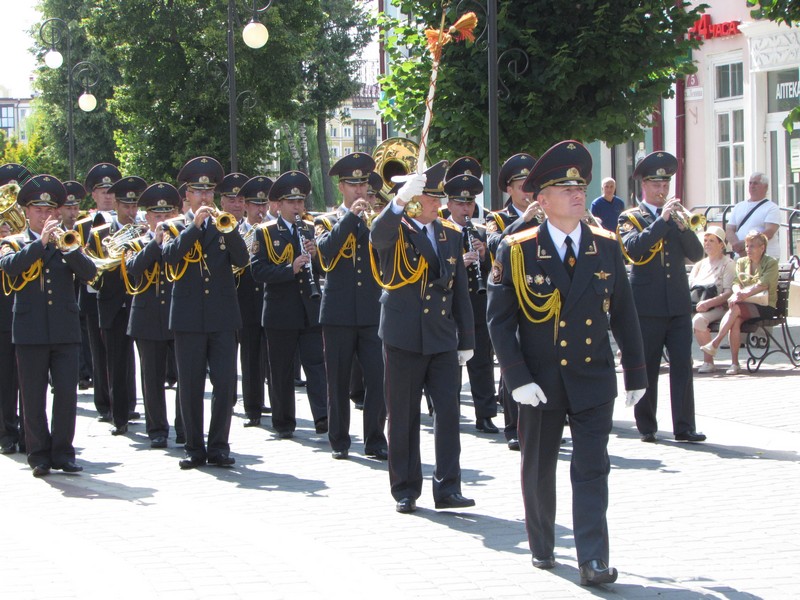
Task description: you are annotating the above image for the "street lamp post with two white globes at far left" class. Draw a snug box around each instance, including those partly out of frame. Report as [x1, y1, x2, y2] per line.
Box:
[39, 18, 98, 179]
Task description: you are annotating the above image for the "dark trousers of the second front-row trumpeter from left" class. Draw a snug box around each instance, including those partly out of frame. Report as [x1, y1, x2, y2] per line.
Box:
[174, 329, 236, 460]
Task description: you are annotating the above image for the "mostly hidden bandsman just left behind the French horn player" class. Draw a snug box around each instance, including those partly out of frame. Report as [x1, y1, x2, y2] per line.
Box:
[78, 163, 122, 423]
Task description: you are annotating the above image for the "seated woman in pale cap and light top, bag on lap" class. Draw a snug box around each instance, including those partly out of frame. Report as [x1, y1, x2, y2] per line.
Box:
[689, 226, 736, 373]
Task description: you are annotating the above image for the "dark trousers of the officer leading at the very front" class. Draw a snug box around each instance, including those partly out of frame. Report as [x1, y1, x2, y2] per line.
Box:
[519, 402, 614, 565]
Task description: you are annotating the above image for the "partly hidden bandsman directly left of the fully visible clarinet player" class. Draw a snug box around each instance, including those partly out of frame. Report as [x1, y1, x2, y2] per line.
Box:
[237, 175, 273, 427]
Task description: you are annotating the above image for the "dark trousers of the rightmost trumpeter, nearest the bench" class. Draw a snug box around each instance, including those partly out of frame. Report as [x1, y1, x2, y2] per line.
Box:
[633, 315, 696, 434]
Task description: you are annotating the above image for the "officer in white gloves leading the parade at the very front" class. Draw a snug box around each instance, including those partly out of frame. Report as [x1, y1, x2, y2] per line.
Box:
[489, 141, 647, 585]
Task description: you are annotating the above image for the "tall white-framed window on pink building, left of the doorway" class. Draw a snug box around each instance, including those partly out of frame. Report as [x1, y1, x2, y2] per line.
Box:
[714, 60, 746, 204]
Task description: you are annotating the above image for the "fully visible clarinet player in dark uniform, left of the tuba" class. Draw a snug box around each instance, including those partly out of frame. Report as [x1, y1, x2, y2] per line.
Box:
[251, 171, 328, 439]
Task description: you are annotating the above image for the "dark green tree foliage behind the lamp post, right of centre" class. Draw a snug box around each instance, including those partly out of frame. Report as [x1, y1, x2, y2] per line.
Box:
[378, 0, 705, 161]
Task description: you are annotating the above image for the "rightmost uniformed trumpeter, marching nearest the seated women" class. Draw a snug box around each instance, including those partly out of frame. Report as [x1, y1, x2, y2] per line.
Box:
[618, 152, 706, 443]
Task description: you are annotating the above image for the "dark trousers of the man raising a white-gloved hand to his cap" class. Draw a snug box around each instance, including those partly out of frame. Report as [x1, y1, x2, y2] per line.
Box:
[383, 344, 461, 500]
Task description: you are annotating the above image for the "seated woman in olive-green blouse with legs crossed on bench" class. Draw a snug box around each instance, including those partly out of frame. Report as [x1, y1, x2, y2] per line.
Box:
[700, 231, 778, 375]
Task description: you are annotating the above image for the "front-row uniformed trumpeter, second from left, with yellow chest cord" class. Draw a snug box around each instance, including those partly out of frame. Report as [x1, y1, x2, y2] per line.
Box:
[163, 156, 248, 469]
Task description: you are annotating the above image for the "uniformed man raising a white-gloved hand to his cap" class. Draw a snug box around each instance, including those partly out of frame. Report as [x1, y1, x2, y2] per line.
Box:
[370, 161, 475, 513]
